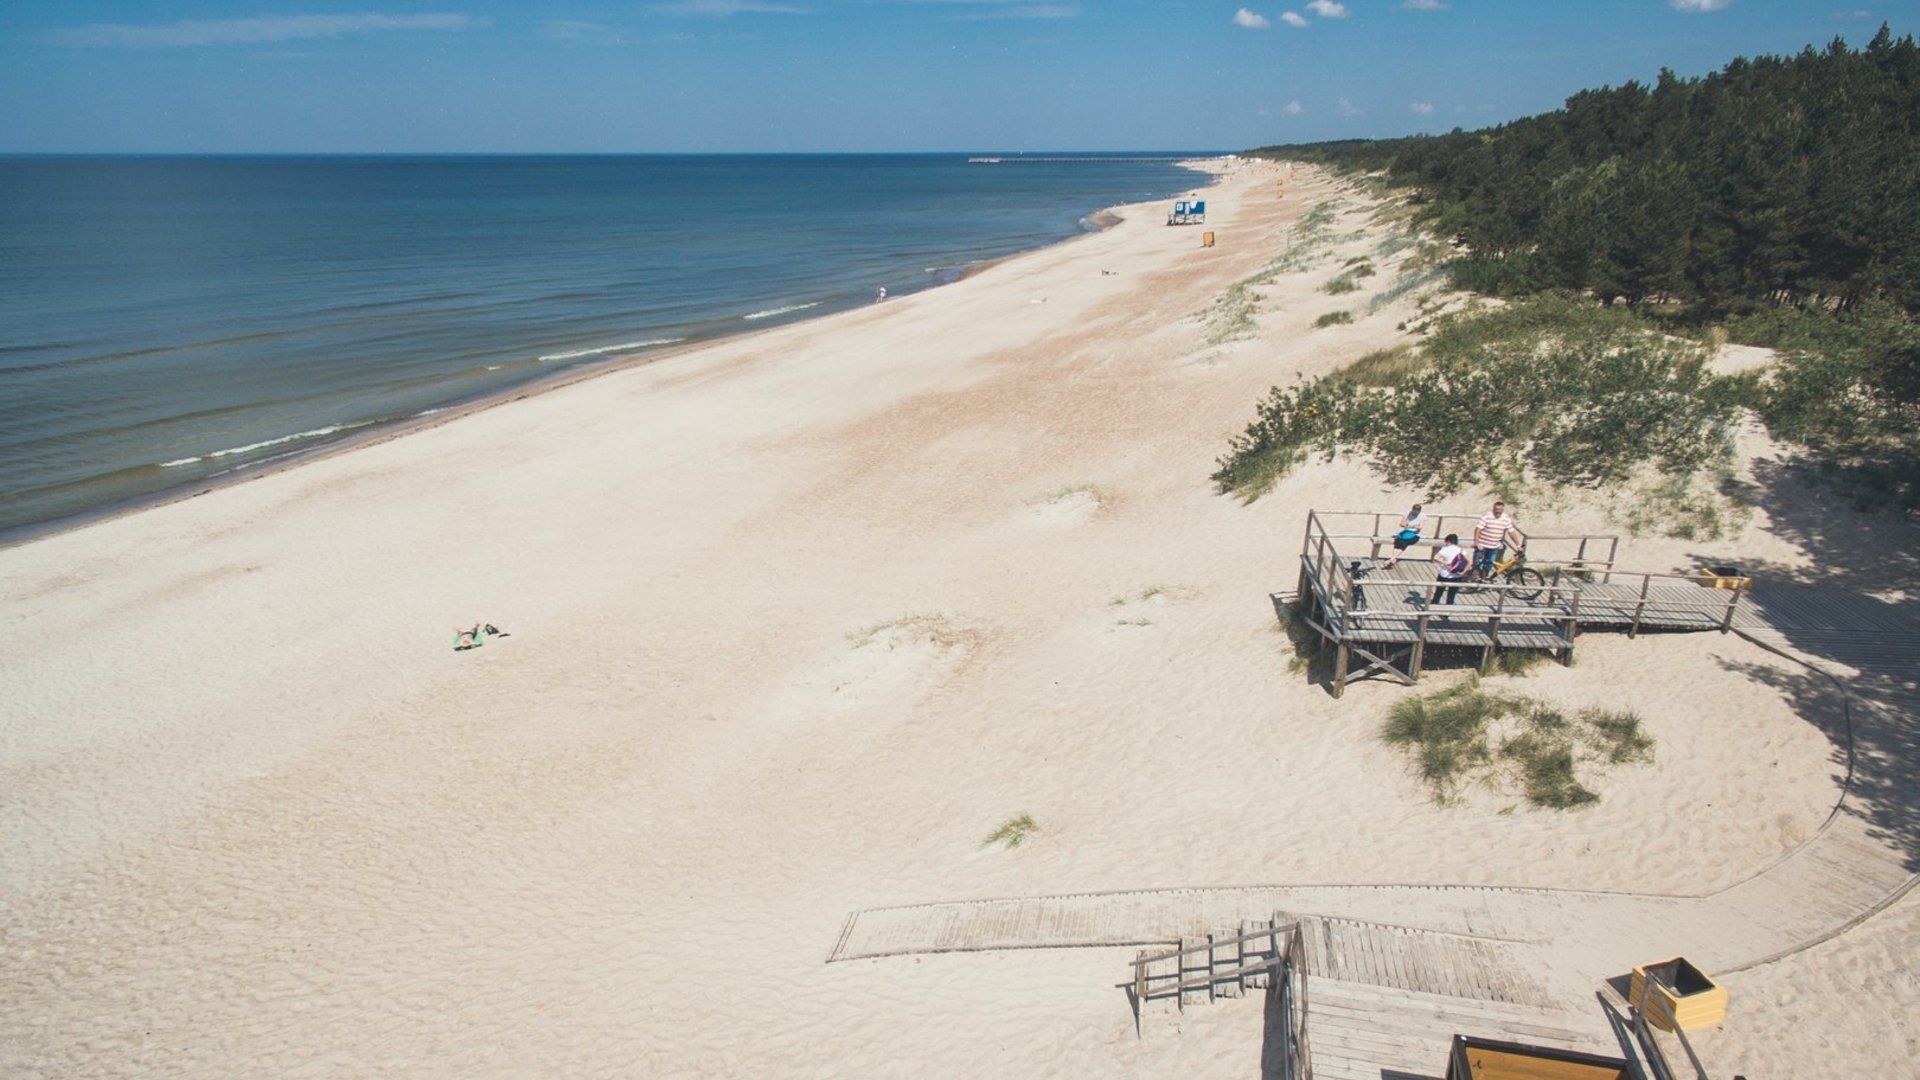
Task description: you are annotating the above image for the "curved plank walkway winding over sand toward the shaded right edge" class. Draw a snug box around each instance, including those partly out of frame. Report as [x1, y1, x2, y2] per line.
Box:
[829, 586, 1920, 1042]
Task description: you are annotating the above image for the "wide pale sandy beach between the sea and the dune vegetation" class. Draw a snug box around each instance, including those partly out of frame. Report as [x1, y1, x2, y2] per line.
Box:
[0, 161, 1920, 1076]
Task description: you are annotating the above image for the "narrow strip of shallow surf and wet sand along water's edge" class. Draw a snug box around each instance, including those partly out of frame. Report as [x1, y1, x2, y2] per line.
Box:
[0, 156, 1227, 552]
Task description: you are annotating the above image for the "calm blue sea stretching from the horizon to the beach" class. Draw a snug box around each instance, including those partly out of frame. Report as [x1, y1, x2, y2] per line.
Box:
[0, 156, 1200, 532]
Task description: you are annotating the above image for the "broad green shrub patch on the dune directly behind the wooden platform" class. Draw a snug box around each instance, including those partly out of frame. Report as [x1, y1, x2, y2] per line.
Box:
[1213, 296, 1738, 498]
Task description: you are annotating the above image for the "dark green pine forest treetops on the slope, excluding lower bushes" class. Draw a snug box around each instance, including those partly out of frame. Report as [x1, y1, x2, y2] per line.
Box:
[1258, 27, 1920, 311]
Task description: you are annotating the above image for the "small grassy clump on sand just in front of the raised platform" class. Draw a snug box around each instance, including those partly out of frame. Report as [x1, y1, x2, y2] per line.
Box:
[1380, 680, 1653, 809]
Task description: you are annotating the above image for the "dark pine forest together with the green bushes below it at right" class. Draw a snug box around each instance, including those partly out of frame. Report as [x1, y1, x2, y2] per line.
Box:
[1256, 25, 1920, 511]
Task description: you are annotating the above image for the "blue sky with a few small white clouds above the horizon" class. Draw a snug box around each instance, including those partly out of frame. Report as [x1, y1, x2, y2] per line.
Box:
[0, 0, 1920, 154]
